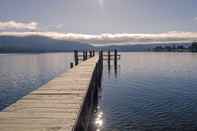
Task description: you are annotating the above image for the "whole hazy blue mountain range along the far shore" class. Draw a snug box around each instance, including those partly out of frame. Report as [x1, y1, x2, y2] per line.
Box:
[0, 36, 191, 53]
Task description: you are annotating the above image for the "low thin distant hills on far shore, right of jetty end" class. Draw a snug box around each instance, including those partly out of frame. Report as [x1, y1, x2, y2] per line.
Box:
[97, 43, 191, 52]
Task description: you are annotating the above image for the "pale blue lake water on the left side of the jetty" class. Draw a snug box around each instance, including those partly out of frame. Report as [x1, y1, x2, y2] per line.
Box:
[0, 53, 72, 110]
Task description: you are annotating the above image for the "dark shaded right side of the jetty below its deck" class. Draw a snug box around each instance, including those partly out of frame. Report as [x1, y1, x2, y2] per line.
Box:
[73, 60, 103, 131]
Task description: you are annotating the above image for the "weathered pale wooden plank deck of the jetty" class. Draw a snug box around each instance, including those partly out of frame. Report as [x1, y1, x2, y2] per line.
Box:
[0, 56, 99, 131]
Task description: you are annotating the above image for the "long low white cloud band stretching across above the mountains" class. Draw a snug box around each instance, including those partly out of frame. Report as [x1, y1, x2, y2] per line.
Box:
[0, 31, 197, 44]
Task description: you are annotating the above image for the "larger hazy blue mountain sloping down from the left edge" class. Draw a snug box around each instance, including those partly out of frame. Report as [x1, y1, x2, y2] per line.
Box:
[0, 36, 94, 53]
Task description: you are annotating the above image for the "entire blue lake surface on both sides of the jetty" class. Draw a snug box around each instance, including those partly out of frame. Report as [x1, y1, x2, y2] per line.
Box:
[0, 53, 197, 131]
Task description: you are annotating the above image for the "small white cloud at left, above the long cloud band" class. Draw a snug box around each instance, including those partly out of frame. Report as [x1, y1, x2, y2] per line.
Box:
[0, 21, 38, 30]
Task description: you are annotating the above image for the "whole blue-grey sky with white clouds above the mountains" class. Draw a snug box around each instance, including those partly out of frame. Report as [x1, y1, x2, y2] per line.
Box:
[0, 0, 197, 43]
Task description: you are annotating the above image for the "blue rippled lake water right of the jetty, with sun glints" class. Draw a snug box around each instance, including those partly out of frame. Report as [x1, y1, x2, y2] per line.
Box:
[94, 53, 197, 131]
